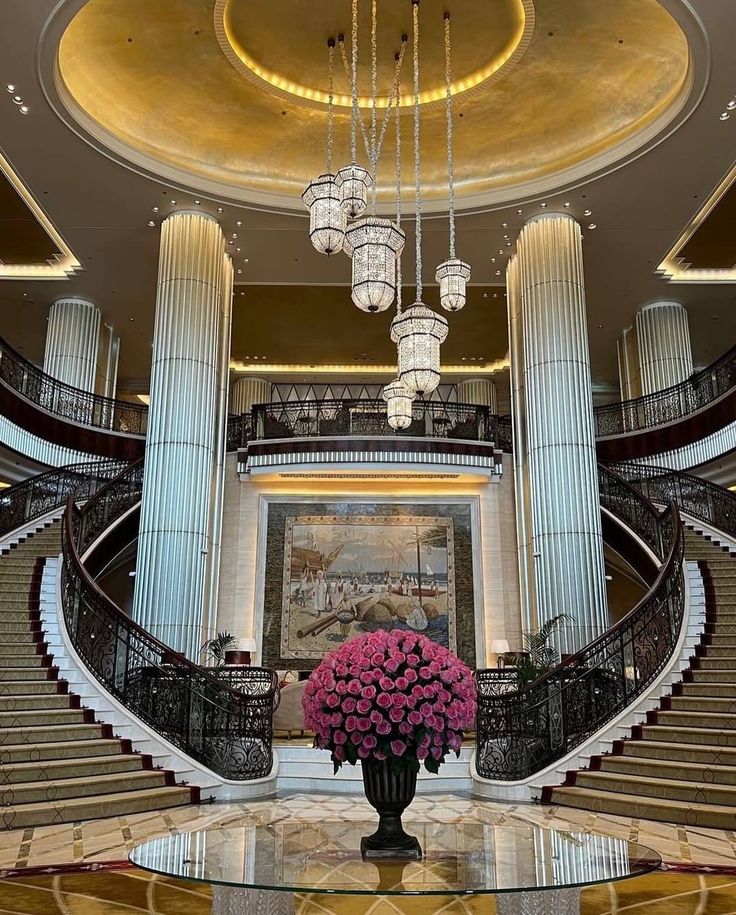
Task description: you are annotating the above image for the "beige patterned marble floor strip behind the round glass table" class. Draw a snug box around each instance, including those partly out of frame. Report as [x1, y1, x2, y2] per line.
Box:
[0, 794, 736, 872]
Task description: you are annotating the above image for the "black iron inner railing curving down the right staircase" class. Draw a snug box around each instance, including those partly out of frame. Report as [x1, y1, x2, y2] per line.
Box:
[476, 467, 685, 781]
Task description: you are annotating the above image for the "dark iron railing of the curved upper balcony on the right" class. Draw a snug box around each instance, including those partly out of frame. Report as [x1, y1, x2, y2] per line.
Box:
[594, 346, 736, 438]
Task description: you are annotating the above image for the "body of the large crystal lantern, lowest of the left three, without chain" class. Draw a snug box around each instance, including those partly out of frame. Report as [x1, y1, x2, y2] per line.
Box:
[343, 216, 406, 314]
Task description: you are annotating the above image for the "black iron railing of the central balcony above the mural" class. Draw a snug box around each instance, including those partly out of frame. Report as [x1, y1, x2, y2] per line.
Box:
[250, 398, 511, 451]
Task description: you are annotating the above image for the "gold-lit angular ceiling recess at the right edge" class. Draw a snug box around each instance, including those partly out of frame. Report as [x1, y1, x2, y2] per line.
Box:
[657, 164, 736, 283]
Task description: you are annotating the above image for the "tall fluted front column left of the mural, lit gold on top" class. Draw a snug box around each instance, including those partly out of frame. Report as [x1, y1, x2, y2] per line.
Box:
[134, 213, 231, 659]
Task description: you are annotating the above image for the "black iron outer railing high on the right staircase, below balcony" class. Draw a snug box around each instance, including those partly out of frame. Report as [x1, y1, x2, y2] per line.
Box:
[610, 463, 736, 537]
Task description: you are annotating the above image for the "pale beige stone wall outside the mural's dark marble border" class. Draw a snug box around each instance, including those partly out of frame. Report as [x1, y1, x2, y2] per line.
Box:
[217, 455, 521, 667]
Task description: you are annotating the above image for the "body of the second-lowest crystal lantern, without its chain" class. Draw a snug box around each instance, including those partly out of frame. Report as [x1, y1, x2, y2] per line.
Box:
[391, 302, 449, 396]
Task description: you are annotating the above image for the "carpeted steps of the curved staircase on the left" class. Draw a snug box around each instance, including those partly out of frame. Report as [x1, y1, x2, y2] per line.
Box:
[0, 522, 199, 829]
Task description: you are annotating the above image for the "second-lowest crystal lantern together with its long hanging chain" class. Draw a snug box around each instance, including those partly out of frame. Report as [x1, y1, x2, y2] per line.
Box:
[391, 3, 449, 395]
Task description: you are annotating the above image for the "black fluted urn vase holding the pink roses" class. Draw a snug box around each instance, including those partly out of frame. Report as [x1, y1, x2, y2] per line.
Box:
[360, 759, 422, 861]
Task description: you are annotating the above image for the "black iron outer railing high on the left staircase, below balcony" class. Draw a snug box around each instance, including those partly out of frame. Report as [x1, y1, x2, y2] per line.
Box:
[0, 461, 126, 536]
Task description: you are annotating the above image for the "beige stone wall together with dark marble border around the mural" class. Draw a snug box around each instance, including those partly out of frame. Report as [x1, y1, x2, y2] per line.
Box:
[217, 455, 521, 669]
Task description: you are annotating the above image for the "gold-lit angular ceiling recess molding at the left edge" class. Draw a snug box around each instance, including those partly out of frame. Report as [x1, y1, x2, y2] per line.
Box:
[0, 152, 82, 280]
